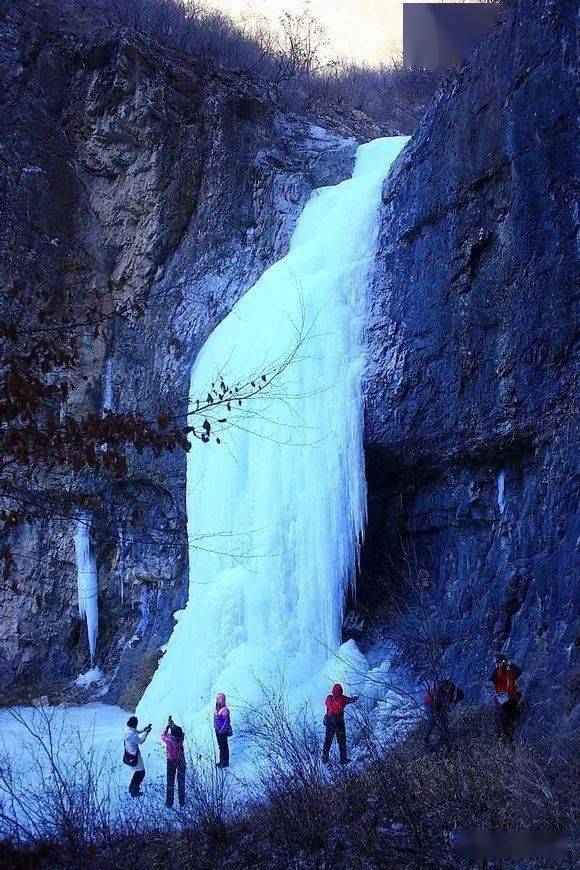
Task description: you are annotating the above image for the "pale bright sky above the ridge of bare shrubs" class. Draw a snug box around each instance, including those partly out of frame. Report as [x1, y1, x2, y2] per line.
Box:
[208, 0, 412, 66]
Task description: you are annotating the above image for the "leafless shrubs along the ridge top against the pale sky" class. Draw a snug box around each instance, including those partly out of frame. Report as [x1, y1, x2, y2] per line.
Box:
[78, 0, 441, 130]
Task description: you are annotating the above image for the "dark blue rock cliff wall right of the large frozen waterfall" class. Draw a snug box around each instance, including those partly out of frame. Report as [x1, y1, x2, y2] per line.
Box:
[365, 2, 577, 709]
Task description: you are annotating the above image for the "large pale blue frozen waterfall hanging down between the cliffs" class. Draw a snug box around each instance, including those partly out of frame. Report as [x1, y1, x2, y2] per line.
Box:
[137, 137, 406, 730]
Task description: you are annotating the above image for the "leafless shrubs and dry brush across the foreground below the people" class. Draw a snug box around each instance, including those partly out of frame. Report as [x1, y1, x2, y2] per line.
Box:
[0, 691, 577, 870]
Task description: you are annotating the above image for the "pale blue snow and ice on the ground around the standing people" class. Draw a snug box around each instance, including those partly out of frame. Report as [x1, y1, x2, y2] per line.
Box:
[0, 660, 420, 838]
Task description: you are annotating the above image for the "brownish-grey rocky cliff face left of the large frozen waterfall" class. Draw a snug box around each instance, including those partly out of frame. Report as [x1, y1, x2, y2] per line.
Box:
[0, 3, 385, 704]
